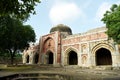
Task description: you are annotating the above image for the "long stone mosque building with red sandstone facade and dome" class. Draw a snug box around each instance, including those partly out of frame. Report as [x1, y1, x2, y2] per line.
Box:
[23, 24, 120, 67]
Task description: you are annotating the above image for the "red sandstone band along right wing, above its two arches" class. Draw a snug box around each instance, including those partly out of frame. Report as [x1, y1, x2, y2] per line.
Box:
[62, 32, 108, 51]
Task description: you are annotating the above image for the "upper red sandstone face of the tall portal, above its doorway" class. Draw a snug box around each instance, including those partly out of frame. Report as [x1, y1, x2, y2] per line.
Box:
[40, 32, 61, 63]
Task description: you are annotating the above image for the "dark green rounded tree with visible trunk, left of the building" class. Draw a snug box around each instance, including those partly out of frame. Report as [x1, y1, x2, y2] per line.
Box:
[0, 16, 35, 64]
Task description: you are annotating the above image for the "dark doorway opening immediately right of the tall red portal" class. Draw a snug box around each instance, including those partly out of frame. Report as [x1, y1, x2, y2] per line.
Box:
[68, 51, 78, 65]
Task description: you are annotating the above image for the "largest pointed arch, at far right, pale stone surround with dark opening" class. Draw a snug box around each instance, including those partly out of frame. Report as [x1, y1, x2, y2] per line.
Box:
[91, 43, 115, 66]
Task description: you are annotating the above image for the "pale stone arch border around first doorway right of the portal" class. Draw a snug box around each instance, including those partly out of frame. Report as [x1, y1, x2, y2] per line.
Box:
[64, 47, 79, 65]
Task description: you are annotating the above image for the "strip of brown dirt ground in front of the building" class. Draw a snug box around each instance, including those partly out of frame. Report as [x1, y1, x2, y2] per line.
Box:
[0, 65, 120, 80]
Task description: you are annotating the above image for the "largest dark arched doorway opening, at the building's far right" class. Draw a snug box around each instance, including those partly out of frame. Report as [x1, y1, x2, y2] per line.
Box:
[96, 48, 112, 66]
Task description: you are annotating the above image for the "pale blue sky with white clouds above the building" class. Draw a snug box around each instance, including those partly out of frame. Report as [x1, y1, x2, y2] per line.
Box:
[25, 0, 120, 43]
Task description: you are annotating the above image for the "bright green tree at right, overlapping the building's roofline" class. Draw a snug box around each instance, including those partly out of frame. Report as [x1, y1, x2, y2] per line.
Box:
[102, 4, 120, 44]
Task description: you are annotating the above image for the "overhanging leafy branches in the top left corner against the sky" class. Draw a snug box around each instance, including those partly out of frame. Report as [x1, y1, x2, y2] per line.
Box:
[0, 0, 40, 20]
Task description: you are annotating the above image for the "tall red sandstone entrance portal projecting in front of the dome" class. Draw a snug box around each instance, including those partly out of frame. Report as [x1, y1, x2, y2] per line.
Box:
[39, 31, 61, 65]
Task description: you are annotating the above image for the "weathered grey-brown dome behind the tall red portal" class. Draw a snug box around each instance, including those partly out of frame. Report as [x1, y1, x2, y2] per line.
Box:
[50, 24, 72, 34]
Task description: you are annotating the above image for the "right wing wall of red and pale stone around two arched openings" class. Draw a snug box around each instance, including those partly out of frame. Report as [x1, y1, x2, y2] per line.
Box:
[61, 27, 120, 67]
